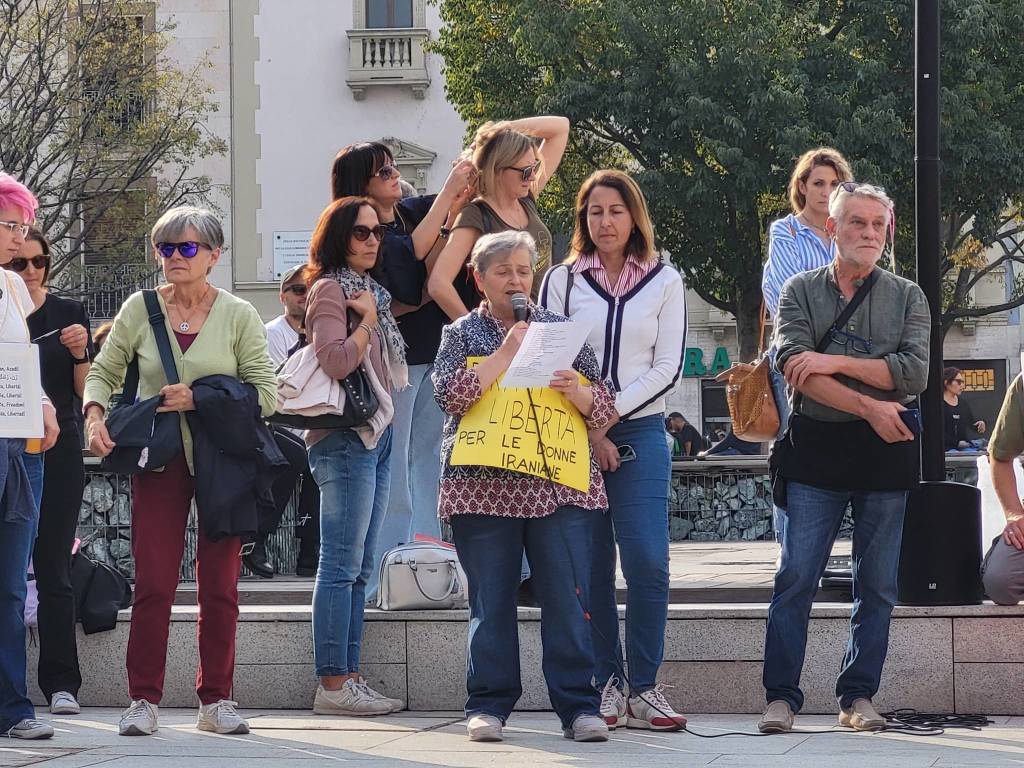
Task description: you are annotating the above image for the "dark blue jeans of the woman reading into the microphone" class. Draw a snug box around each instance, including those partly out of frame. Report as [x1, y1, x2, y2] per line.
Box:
[451, 507, 601, 728]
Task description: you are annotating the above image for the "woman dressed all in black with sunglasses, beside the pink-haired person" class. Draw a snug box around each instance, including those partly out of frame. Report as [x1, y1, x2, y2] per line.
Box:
[7, 229, 92, 715]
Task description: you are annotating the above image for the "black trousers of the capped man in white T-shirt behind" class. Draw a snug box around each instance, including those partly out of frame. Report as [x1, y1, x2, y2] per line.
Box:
[268, 427, 319, 567]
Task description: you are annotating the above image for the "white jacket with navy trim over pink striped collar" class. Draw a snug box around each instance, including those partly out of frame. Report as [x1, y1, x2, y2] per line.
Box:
[540, 264, 686, 421]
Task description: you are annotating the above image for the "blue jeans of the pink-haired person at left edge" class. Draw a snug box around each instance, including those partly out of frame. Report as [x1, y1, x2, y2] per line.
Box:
[0, 451, 42, 733]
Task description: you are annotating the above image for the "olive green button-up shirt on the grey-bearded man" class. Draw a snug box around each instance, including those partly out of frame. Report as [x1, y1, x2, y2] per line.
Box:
[775, 262, 931, 422]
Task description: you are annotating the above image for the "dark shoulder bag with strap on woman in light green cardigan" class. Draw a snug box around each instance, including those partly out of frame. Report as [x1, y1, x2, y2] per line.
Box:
[99, 289, 182, 475]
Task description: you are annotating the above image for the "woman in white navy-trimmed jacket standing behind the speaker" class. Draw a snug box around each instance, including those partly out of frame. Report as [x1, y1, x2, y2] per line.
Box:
[541, 170, 686, 730]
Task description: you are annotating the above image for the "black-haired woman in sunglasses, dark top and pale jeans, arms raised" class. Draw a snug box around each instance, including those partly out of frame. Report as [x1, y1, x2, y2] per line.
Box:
[331, 142, 475, 597]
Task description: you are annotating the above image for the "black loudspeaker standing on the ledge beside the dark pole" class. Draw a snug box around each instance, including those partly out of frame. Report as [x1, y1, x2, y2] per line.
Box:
[899, 481, 984, 605]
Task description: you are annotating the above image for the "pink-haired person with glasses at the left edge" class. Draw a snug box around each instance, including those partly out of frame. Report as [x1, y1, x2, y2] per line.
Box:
[0, 173, 59, 738]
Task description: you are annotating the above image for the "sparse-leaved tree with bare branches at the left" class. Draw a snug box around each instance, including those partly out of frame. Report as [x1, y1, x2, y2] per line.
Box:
[0, 0, 226, 308]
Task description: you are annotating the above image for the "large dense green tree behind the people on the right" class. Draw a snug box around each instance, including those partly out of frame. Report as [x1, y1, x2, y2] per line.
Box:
[435, 0, 1024, 357]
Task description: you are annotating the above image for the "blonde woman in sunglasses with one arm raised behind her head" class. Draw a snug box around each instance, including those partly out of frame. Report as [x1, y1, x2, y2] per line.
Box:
[427, 117, 569, 319]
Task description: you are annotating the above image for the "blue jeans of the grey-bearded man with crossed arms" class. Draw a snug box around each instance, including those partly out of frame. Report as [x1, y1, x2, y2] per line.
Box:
[763, 482, 907, 712]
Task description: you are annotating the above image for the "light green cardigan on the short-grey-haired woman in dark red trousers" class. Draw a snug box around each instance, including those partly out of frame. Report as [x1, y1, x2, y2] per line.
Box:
[82, 290, 278, 474]
